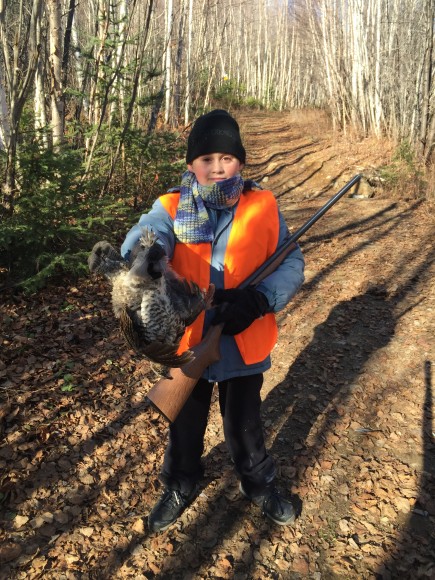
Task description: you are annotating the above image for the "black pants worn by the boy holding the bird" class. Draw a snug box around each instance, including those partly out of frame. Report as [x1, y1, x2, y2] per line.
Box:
[161, 374, 275, 495]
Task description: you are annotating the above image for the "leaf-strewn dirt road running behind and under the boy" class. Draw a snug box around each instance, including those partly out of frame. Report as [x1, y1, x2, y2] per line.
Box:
[0, 113, 435, 580]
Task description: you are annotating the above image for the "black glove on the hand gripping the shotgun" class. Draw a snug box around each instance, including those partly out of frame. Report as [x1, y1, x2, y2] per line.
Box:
[212, 286, 270, 336]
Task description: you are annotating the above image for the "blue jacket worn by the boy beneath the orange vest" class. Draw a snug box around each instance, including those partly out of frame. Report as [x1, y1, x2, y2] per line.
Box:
[121, 193, 304, 382]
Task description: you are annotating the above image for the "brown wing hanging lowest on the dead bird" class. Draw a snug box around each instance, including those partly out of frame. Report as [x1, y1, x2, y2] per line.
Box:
[119, 308, 193, 368]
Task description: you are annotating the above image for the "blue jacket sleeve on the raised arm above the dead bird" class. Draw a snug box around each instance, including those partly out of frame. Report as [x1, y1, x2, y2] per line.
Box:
[121, 199, 175, 260]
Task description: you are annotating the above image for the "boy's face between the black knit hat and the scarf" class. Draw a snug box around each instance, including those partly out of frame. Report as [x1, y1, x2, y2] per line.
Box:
[187, 153, 244, 185]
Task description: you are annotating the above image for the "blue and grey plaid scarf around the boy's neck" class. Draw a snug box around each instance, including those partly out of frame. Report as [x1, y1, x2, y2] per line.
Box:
[174, 171, 244, 244]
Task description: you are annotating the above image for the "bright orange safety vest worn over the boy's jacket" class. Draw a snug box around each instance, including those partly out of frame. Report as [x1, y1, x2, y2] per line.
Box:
[160, 190, 279, 364]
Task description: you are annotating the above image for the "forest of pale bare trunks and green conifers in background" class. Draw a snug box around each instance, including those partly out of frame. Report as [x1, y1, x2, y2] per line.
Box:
[0, 0, 435, 288]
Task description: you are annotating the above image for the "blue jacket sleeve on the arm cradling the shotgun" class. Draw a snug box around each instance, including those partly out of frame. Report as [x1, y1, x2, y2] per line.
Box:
[257, 210, 305, 312]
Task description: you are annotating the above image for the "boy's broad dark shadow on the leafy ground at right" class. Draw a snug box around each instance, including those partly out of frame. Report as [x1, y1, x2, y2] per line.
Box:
[264, 286, 395, 460]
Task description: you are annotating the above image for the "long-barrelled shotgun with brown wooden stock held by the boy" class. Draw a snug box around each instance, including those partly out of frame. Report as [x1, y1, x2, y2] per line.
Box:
[147, 175, 361, 423]
